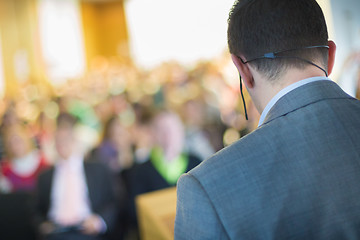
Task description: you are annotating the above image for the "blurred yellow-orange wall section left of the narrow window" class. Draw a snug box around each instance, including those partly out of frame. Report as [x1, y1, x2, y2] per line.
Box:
[0, 0, 46, 98]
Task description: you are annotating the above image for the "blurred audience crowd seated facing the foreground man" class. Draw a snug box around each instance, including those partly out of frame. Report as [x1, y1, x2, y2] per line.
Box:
[0, 56, 258, 239]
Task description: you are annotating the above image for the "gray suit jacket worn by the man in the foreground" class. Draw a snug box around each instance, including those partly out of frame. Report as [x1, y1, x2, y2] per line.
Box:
[175, 81, 360, 239]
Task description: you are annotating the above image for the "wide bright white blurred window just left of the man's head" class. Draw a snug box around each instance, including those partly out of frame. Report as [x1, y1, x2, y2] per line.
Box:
[125, 0, 234, 68]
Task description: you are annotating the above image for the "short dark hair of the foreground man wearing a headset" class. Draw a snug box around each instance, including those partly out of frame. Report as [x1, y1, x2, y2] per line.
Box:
[228, 0, 328, 80]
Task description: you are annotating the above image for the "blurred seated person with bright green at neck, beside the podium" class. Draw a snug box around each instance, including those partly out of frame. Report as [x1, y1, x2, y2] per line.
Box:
[129, 111, 201, 236]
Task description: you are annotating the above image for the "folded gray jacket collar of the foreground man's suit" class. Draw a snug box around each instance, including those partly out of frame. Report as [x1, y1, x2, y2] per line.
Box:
[262, 81, 353, 125]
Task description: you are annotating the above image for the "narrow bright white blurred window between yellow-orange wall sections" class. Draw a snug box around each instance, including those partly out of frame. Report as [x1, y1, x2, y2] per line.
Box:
[38, 0, 85, 84]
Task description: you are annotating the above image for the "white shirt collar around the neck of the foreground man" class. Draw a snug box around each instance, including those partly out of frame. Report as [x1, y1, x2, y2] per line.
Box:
[258, 77, 331, 126]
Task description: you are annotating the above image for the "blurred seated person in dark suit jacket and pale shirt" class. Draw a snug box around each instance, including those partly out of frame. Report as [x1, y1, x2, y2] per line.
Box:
[37, 113, 117, 240]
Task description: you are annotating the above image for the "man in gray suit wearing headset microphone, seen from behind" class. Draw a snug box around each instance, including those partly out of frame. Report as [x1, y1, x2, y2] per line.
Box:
[175, 0, 360, 239]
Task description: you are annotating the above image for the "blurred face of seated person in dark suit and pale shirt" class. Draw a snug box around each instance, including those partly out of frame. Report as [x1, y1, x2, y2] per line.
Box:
[55, 128, 75, 160]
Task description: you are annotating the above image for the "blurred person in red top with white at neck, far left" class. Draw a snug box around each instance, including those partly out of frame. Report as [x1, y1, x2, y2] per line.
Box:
[0, 124, 48, 192]
